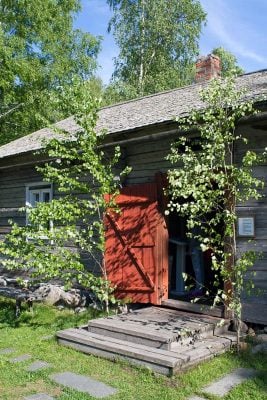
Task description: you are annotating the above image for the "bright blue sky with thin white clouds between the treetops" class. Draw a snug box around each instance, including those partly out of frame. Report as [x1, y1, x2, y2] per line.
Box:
[75, 0, 267, 83]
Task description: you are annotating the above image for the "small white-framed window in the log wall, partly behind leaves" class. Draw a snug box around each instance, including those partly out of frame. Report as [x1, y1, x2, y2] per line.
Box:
[26, 182, 53, 227]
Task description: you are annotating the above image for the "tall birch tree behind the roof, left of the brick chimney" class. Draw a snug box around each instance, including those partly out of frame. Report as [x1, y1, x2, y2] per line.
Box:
[107, 0, 205, 98]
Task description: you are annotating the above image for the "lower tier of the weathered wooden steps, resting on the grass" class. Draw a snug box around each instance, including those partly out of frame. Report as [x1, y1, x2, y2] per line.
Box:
[57, 328, 237, 375]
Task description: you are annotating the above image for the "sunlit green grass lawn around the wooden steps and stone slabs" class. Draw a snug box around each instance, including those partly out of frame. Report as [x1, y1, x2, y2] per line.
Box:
[0, 299, 267, 400]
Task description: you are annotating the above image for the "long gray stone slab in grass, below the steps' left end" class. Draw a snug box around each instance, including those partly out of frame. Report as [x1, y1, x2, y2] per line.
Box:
[50, 372, 117, 398]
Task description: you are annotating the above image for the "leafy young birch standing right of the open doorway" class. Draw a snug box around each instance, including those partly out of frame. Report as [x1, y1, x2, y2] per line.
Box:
[167, 77, 265, 346]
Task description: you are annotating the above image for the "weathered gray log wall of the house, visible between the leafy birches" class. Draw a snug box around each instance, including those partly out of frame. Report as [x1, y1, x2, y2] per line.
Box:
[0, 120, 267, 324]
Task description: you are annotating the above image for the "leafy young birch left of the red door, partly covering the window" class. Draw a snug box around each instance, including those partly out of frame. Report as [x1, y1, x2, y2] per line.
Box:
[0, 83, 130, 310]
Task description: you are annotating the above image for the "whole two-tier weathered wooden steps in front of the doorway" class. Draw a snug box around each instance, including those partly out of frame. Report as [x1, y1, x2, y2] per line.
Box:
[57, 307, 235, 375]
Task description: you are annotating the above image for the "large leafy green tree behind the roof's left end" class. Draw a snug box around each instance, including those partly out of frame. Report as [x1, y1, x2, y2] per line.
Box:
[0, 0, 100, 144]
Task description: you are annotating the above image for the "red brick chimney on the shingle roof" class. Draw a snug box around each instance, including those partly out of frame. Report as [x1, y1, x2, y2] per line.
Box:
[195, 54, 221, 83]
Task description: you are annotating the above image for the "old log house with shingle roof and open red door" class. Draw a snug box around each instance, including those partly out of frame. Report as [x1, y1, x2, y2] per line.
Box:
[0, 57, 267, 324]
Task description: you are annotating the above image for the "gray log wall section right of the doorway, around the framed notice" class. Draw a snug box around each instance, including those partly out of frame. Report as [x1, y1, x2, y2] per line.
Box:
[235, 123, 267, 324]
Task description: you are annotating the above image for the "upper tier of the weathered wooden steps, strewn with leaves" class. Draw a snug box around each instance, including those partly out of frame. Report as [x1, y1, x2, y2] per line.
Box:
[87, 309, 228, 350]
